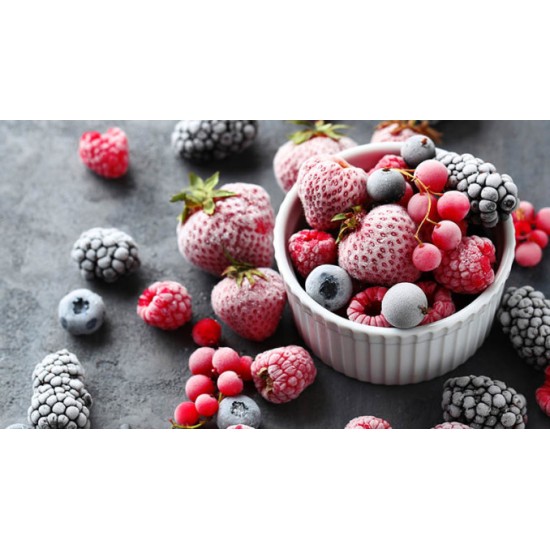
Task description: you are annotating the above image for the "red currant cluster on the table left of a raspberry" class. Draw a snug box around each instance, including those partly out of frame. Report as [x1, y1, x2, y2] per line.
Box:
[170, 347, 253, 428]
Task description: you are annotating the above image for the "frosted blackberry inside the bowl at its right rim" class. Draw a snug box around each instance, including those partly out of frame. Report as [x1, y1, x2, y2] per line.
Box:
[436, 150, 519, 227]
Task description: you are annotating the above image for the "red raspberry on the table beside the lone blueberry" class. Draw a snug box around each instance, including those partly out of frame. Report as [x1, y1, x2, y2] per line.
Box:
[137, 281, 192, 330]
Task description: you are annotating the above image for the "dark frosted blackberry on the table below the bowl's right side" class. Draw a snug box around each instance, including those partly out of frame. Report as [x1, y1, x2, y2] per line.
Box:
[441, 374, 527, 428]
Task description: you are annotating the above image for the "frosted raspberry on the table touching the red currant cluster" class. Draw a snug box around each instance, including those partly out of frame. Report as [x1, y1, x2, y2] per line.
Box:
[252, 346, 317, 403]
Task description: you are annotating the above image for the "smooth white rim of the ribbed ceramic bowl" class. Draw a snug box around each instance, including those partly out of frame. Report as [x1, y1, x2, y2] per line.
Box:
[274, 142, 515, 337]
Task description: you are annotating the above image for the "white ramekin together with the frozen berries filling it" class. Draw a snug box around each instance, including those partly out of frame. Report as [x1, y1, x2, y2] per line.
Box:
[275, 140, 519, 384]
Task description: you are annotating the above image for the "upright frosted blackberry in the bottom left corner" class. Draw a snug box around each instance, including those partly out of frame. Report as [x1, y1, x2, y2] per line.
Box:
[28, 349, 92, 429]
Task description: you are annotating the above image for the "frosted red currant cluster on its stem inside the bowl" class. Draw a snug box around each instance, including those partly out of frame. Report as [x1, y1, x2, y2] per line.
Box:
[399, 160, 470, 271]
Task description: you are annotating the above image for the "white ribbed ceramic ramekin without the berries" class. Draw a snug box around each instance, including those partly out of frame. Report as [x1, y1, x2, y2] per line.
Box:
[275, 143, 515, 385]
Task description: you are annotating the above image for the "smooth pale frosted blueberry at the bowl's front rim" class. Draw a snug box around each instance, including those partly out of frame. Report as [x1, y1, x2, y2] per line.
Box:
[382, 283, 428, 328]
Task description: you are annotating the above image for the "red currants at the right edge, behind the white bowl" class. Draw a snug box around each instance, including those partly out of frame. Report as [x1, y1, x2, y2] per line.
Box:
[512, 205, 550, 267]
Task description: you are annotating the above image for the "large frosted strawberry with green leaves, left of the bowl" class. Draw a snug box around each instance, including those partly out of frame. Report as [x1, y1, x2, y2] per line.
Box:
[171, 172, 275, 276]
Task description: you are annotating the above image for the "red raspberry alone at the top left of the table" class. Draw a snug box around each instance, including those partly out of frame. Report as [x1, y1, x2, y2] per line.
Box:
[78, 128, 129, 179]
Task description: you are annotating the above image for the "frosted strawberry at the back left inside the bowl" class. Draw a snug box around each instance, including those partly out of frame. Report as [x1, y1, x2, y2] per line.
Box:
[296, 156, 367, 231]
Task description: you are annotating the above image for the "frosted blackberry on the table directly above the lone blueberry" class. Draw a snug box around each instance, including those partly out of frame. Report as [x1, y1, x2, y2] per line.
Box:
[71, 227, 140, 283]
